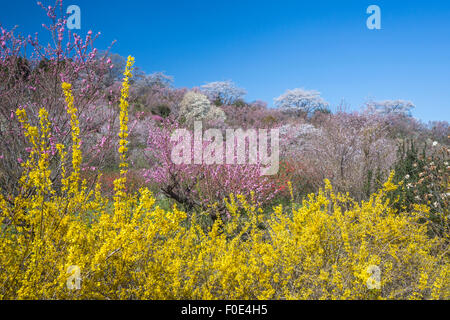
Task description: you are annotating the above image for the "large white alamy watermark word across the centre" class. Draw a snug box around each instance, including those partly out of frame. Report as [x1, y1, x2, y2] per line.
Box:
[171, 121, 280, 176]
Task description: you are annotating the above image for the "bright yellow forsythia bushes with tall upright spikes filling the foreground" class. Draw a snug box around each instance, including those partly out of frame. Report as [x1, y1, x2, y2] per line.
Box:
[0, 58, 450, 299]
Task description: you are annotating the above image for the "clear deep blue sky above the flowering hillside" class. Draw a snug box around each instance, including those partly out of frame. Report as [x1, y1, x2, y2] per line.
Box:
[0, 0, 450, 121]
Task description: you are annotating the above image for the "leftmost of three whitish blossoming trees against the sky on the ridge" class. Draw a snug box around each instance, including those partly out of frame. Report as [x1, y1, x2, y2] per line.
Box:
[201, 81, 247, 105]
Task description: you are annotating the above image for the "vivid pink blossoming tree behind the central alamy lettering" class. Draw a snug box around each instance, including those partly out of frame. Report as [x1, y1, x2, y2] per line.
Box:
[144, 120, 277, 218]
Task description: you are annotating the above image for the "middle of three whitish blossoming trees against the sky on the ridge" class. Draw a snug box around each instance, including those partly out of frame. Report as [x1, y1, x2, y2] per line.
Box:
[274, 88, 328, 115]
